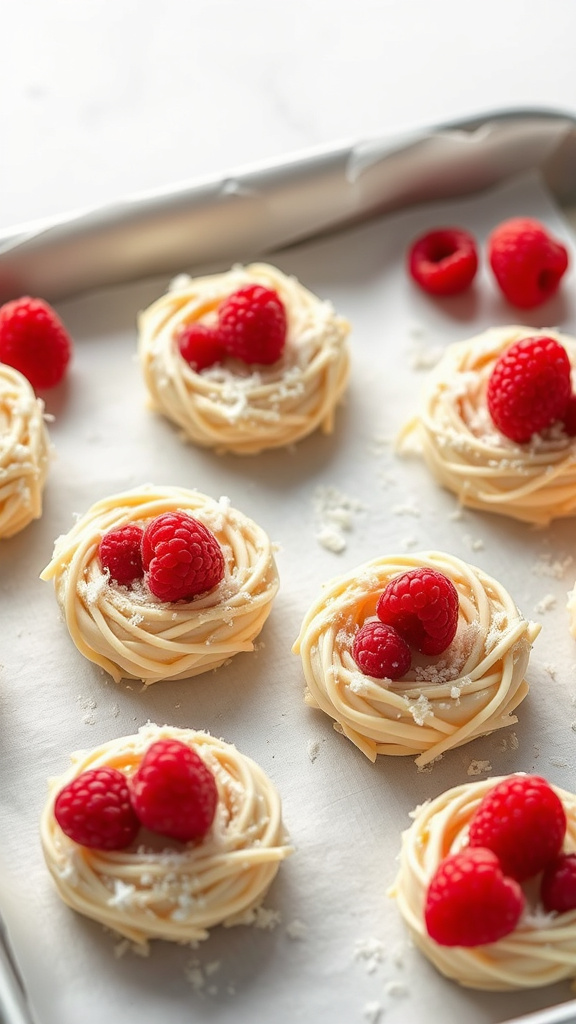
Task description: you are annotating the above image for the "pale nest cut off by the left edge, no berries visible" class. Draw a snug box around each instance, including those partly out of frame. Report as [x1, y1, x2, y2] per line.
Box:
[0, 362, 51, 538]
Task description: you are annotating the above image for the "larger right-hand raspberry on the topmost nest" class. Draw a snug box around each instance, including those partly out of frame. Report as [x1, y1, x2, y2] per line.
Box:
[218, 285, 287, 365]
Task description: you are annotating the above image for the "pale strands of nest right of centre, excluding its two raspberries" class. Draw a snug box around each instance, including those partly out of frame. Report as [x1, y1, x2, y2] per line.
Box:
[293, 552, 540, 767]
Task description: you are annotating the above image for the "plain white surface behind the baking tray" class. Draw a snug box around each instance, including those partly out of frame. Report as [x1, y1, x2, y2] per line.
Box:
[0, 0, 576, 227]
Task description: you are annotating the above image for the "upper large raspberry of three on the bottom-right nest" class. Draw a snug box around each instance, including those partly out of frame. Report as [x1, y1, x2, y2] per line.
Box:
[468, 775, 566, 882]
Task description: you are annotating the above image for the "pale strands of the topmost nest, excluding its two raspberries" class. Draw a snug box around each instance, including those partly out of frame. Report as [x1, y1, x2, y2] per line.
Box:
[138, 263, 349, 455]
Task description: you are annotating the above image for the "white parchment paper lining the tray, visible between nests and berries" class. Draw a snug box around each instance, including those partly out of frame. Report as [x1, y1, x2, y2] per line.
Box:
[0, 174, 576, 1024]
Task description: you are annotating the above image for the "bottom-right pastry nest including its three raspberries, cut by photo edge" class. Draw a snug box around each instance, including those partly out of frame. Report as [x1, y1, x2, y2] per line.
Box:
[389, 773, 576, 991]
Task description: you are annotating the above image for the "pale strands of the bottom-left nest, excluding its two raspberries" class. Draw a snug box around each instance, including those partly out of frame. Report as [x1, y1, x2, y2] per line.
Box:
[41, 725, 292, 944]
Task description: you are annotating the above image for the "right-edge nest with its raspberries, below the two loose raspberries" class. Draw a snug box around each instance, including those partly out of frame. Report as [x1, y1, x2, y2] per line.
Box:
[398, 326, 576, 525]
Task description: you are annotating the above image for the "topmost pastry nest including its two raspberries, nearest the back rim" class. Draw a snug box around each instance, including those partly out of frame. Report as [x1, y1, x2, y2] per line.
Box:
[138, 263, 349, 455]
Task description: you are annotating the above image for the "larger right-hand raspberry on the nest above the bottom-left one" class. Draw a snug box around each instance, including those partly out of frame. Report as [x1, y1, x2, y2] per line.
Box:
[142, 512, 224, 601]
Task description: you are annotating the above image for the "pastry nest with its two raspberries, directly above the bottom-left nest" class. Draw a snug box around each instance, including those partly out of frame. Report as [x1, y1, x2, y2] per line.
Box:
[41, 486, 279, 685]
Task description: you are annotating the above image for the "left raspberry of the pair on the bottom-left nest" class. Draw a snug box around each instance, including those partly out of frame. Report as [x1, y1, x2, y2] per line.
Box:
[54, 768, 139, 850]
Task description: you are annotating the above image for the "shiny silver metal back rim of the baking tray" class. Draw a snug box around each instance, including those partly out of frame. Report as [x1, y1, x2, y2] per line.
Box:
[0, 109, 576, 301]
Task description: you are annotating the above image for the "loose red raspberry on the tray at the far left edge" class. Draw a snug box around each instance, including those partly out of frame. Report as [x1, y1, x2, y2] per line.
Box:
[0, 295, 72, 388]
